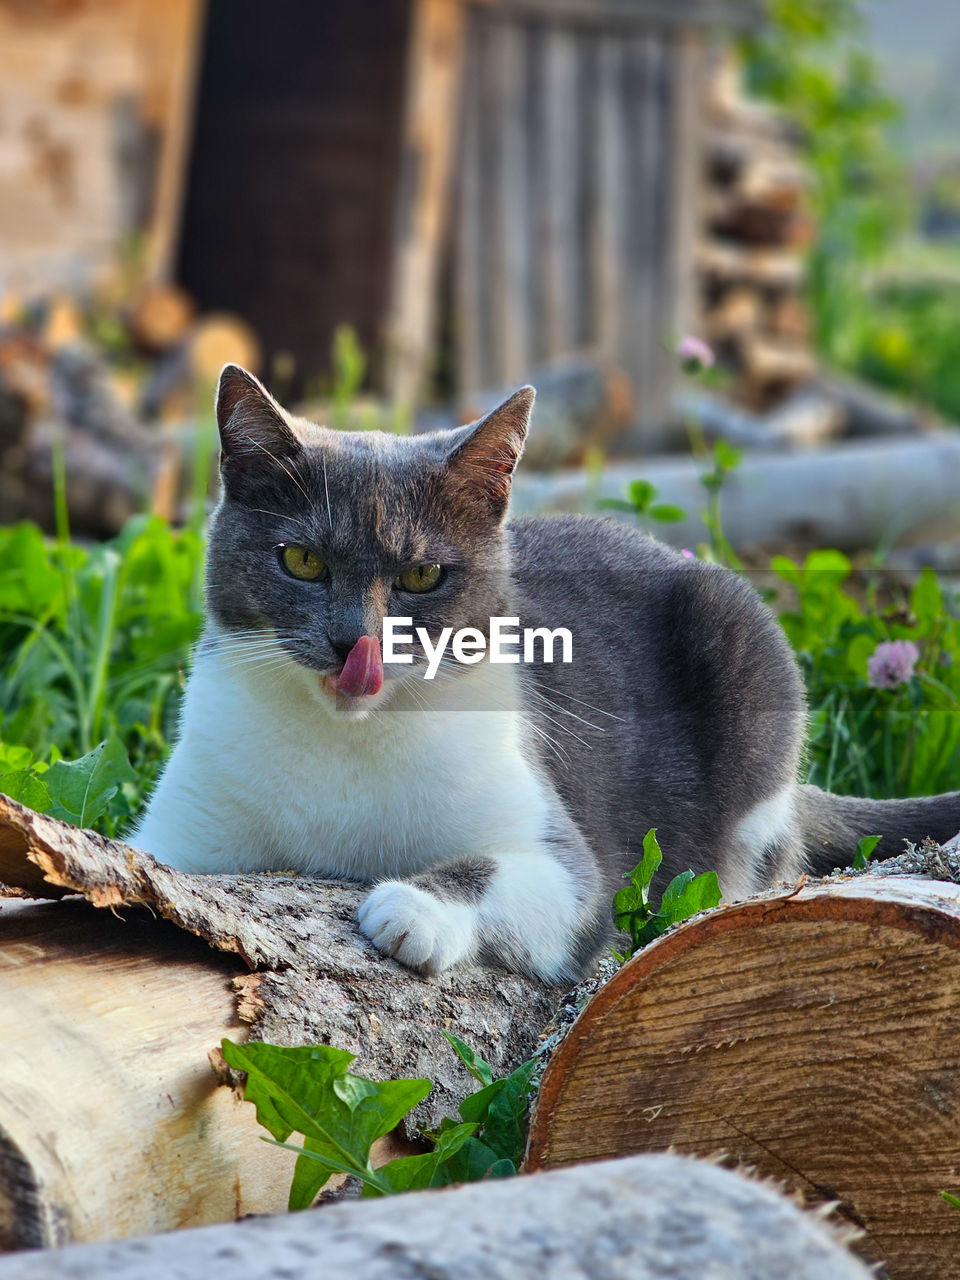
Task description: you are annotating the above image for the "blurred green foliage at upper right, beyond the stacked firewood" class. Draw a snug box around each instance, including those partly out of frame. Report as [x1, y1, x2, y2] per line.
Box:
[744, 0, 960, 419]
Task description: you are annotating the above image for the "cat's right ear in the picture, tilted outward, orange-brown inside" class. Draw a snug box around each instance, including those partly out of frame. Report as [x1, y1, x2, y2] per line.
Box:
[447, 387, 536, 516]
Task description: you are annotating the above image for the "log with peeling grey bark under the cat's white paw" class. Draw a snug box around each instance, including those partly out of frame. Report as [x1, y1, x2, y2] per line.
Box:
[0, 796, 557, 1248]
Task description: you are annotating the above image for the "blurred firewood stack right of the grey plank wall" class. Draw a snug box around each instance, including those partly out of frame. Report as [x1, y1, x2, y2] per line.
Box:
[698, 54, 815, 410]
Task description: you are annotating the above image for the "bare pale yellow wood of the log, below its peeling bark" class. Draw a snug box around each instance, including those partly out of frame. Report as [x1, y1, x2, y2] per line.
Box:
[0, 901, 291, 1249]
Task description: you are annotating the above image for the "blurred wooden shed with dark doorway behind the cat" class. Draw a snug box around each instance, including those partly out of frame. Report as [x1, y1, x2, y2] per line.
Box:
[0, 0, 755, 448]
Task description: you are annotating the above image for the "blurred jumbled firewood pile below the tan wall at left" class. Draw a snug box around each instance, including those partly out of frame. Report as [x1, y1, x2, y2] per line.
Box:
[0, 280, 260, 536]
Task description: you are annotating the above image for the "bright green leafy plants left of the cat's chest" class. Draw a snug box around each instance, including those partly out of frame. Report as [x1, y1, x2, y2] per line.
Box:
[0, 517, 202, 835]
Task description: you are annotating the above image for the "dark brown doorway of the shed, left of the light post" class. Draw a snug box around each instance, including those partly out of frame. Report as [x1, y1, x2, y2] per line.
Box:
[178, 0, 410, 389]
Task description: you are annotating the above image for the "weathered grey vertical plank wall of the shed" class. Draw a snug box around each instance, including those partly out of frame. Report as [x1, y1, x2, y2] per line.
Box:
[451, 4, 703, 444]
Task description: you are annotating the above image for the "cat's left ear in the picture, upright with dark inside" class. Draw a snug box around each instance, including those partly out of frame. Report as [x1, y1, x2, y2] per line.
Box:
[216, 365, 301, 479]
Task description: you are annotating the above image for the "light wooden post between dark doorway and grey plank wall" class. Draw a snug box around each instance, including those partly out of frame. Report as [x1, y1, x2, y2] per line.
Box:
[384, 0, 465, 410]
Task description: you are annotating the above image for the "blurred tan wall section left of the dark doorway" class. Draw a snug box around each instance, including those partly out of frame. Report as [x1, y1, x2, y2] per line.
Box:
[0, 0, 202, 293]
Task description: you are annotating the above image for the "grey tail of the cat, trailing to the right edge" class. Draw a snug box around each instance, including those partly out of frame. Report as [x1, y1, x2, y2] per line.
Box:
[797, 786, 960, 876]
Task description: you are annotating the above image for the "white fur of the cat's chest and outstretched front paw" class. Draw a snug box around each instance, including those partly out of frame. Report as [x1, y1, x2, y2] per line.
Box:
[131, 632, 577, 977]
